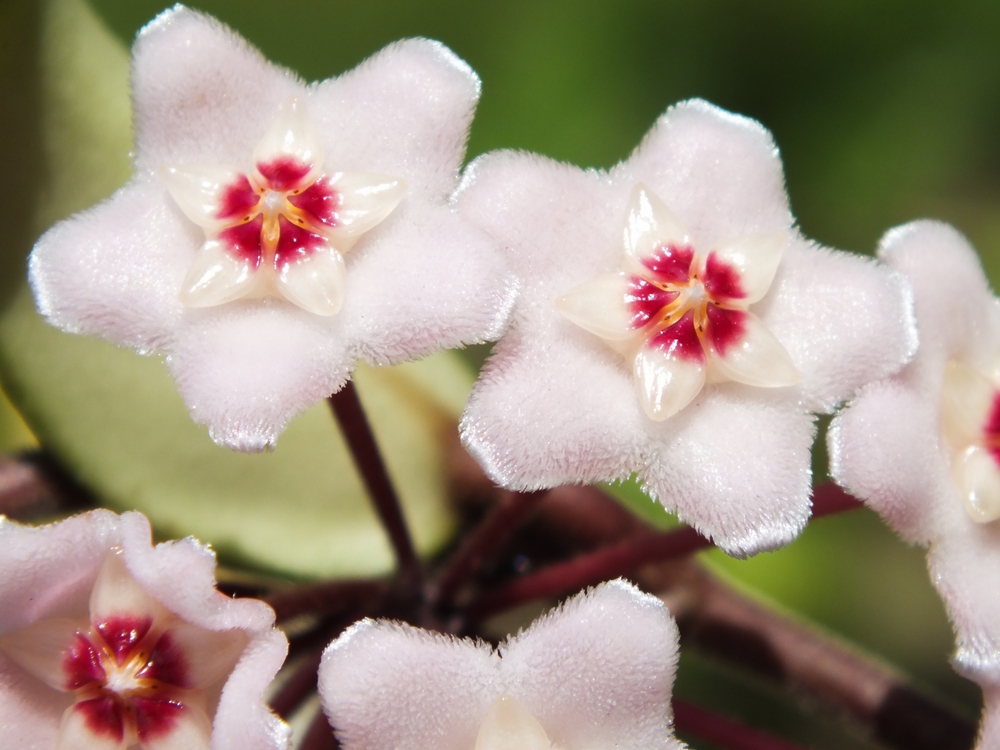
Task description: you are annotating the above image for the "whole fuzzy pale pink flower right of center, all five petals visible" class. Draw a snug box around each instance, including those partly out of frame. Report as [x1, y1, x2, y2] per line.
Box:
[458, 101, 916, 555]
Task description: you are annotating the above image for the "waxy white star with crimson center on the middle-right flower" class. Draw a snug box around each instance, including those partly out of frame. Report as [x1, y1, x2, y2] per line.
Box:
[556, 185, 800, 421]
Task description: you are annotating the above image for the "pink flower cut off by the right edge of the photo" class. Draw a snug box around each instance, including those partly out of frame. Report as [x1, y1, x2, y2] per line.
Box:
[829, 221, 1000, 700]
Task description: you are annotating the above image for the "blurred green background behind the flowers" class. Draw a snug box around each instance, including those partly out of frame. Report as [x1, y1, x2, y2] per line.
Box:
[0, 0, 1000, 747]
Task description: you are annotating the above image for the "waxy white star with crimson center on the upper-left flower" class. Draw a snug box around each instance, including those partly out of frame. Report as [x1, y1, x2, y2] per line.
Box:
[160, 98, 406, 316]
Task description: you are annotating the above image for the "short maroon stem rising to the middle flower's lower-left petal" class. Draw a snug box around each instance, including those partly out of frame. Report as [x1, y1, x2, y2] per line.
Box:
[434, 491, 545, 610]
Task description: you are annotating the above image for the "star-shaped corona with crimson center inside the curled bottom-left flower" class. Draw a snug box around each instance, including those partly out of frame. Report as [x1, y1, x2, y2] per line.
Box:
[0, 548, 248, 750]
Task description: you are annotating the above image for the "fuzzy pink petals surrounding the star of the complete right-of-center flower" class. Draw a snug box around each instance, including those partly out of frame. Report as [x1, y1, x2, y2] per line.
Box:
[455, 100, 916, 555]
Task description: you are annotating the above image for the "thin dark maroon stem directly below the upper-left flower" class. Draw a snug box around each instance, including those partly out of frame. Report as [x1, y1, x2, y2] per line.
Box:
[327, 380, 423, 586]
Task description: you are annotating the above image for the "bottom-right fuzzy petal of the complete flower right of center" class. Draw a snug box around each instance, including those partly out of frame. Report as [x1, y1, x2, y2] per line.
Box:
[640, 384, 816, 557]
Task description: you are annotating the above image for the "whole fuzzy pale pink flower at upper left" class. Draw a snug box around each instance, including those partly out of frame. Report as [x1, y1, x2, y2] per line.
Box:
[31, 7, 515, 450]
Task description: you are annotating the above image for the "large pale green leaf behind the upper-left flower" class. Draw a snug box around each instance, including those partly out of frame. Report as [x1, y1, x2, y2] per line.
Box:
[0, 0, 464, 577]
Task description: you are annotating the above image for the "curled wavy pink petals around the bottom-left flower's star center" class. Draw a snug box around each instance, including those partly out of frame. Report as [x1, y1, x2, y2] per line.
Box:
[0, 510, 291, 750]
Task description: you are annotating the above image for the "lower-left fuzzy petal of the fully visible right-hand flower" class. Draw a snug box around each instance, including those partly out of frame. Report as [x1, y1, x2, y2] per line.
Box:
[459, 326, 646, 490]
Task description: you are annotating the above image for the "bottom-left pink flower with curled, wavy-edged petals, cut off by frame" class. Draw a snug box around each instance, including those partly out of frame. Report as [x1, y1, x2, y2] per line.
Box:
[0, 511, 289, 750]
